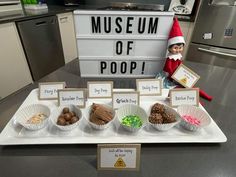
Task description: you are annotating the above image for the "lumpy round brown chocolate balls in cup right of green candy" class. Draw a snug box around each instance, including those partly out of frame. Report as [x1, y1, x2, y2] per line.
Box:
[149, 103, 176, 124]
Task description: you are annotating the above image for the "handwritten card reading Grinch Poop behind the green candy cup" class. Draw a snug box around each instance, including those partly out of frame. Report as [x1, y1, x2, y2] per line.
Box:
[112, 92, 139, 109]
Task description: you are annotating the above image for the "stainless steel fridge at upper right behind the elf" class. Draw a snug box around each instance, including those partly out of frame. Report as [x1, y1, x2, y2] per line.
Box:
[186, 0, 236, 68]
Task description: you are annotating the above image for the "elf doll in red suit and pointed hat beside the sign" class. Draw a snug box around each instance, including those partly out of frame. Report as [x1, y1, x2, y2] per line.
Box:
[157, 18, 212, 101]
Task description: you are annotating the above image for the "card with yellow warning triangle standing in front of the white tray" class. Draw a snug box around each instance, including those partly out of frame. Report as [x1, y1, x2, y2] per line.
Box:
[97, 144, 141, 170]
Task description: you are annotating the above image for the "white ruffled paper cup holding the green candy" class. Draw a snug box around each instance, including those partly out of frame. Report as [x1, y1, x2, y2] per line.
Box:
[116, 104, 147, 133]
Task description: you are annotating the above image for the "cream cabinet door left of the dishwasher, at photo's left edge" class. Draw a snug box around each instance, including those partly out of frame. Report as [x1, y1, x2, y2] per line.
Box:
[0, 23, 32, 99]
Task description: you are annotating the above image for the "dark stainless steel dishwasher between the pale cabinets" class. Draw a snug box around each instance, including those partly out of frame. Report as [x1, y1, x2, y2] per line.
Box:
[17, 16, 65, 81]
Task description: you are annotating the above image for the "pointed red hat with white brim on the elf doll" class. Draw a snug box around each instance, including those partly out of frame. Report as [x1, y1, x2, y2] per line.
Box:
[168, 18, 185, 46]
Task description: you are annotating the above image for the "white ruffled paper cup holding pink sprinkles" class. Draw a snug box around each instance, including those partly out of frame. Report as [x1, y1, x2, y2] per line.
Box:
[177, 105, 211, 131]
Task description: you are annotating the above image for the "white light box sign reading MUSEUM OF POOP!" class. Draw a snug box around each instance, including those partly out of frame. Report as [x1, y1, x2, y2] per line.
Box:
[74, 10, 174, 77]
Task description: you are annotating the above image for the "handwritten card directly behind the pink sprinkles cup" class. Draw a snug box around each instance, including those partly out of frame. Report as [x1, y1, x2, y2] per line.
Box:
[170, 88, 199, 107]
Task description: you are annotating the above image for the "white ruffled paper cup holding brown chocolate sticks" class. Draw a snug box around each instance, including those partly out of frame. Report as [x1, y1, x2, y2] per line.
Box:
[84, 104, 116, 130]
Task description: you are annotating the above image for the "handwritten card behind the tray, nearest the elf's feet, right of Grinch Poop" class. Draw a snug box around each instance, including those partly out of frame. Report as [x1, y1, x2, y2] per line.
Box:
[136, 79, 162, 95]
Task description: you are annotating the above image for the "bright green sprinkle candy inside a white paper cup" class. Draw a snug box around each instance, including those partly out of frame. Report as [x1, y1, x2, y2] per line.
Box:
[121, 115, 143, 128]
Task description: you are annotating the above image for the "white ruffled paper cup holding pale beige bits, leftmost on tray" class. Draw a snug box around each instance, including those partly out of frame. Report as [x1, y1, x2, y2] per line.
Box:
[15, 104, 51, 130]
